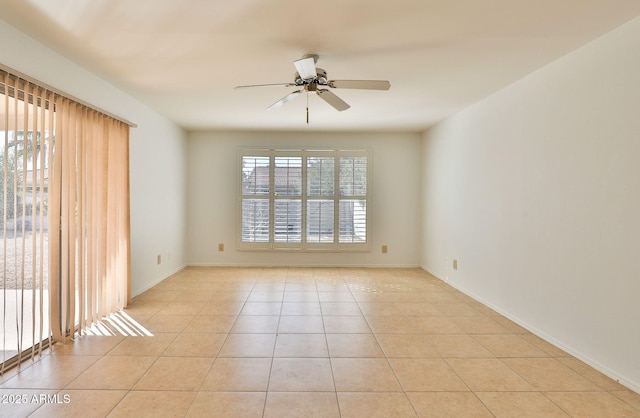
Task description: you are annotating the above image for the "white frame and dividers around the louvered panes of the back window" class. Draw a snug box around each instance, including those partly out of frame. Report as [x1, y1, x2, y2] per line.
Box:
[236, 147, 372, 252]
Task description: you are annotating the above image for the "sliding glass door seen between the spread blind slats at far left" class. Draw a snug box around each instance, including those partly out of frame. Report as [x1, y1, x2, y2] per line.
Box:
[0, 75, 53, 370]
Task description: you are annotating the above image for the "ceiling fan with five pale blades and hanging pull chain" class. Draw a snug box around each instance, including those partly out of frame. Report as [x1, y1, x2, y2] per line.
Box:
[236, 54, 391, 123]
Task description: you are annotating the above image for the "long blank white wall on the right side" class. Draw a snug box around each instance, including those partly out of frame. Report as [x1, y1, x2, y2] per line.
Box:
[422, 18, 640, 391]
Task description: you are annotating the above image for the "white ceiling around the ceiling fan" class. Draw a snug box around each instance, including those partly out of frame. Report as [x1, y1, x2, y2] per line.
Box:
[0, 0, 640, 131]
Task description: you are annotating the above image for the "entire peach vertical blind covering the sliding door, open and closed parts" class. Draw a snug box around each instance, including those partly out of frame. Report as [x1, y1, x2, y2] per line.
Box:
[0, 68, 130, 369]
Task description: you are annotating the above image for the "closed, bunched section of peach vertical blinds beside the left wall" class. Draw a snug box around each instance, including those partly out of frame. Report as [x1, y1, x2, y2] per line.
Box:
[49, 91, 130, 341]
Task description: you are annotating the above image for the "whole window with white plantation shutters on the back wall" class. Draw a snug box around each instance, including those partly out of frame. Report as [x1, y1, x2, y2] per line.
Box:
[239, 149, 370, 250]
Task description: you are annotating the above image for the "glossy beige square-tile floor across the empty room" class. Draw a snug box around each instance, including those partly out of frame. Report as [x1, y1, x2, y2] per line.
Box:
[0, 268, 640, 418]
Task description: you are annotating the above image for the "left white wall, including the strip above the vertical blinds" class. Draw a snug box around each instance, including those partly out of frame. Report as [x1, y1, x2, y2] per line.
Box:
[0, 20, 186, 295]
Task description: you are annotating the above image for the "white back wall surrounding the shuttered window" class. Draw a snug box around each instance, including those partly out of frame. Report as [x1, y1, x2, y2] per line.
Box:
[187, 132, 422, 267]
